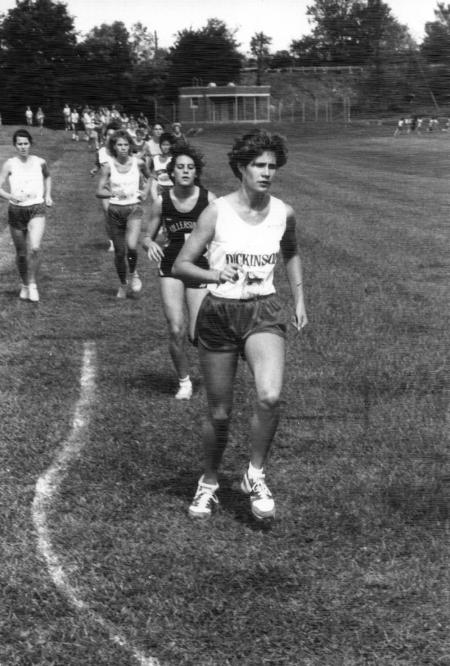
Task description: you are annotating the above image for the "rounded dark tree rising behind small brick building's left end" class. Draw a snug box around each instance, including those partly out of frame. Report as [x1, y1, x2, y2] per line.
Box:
[167, 18, 242, 100]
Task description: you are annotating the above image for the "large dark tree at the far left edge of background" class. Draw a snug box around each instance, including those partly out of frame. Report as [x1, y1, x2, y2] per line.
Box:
[0, 0, 76, 122]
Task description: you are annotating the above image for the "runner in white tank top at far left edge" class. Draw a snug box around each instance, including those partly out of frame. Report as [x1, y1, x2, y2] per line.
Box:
[0, 130, 53, 302]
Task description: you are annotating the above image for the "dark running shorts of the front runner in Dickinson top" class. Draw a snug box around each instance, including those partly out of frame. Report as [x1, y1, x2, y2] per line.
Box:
[196, 294, 286, 353]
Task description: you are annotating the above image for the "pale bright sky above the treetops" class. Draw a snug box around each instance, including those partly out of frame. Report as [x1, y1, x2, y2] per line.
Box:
[0, 0, 437, 53]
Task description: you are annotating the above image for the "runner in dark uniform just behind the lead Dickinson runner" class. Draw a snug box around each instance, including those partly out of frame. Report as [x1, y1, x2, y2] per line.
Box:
[144, 144, 215, 400]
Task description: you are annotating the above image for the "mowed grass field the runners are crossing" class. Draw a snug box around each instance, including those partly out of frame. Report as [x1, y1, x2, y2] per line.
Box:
[0, 125, 450, 666]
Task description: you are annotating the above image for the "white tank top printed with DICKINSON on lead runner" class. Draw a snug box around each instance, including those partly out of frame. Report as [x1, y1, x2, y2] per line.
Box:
[207, 197, 287, 300]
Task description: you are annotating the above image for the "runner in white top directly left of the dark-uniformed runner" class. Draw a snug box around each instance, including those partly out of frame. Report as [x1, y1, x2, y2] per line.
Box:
[97, 130, 150, 298]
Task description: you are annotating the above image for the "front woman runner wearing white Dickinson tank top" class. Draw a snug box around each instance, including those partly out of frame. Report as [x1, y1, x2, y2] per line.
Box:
[173, 130, 307, 520]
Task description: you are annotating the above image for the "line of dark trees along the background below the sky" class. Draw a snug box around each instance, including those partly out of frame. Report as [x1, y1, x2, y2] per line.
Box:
[0, 0, 450, 122]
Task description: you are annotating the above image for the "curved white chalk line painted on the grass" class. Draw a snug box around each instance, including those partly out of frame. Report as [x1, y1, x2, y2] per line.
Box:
[32, 342, 161, 666]
